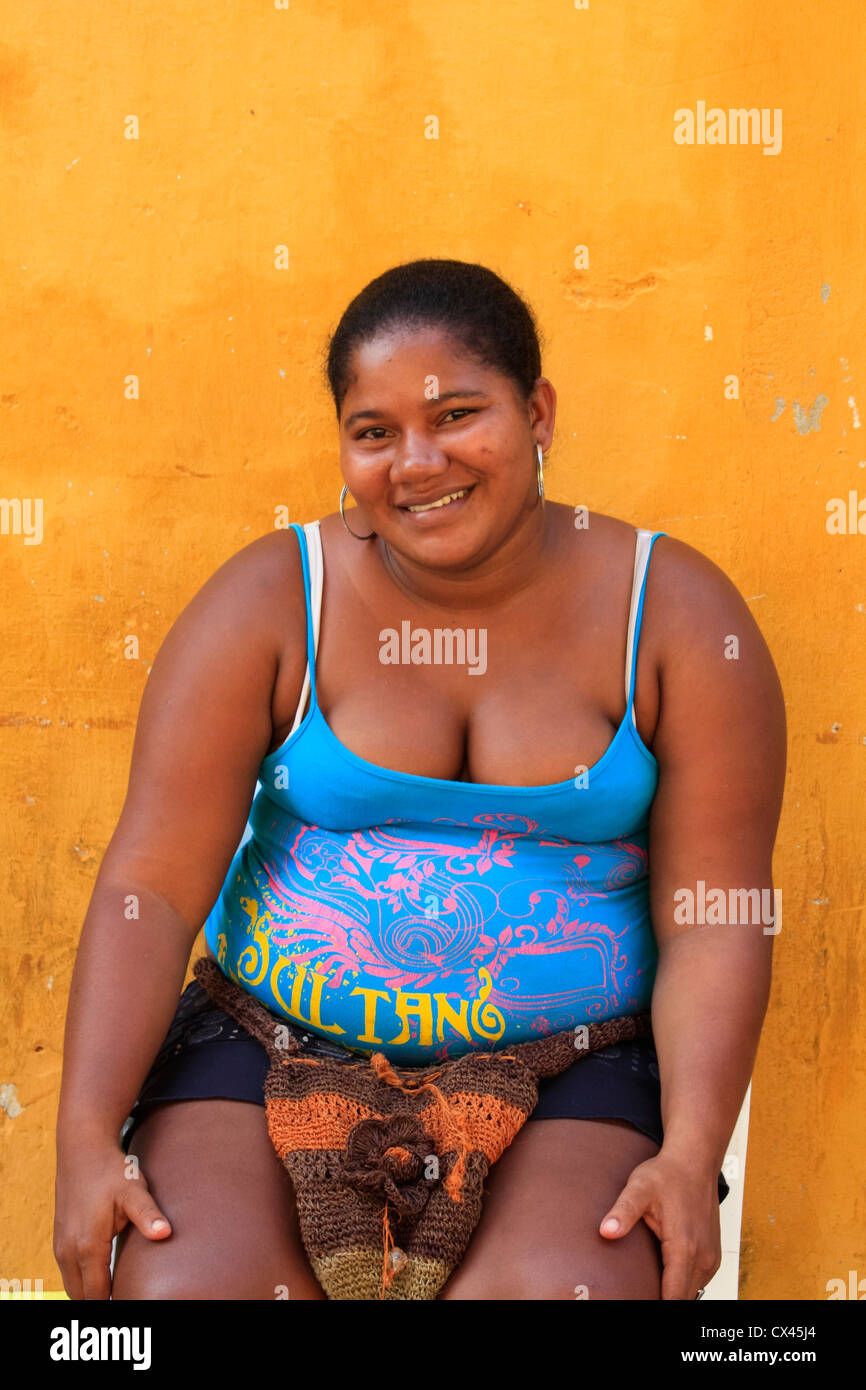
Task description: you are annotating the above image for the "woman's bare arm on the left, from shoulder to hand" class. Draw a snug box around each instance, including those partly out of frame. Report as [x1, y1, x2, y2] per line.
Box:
[54, 534, 300, 1297]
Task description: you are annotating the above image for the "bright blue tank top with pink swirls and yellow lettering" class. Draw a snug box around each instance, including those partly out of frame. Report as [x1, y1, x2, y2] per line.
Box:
[204, 521, 664, 1066]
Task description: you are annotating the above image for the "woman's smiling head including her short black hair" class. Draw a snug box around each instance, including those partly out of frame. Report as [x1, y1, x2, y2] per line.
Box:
[327, 261, 556, 564]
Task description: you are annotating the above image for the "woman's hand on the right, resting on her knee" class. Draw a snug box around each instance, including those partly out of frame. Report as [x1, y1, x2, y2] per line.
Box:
[599, 1145, 721, 1298]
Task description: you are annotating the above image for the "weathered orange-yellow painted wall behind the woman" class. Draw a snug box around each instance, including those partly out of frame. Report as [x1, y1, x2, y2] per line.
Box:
[0, 0, 866, 1300]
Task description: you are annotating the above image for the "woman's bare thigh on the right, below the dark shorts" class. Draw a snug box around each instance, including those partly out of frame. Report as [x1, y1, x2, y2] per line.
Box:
[439, 1119, 662, 1301]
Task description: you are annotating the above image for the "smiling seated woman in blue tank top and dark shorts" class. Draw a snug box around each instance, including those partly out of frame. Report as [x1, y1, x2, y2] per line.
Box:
[56, 260, 785, 1300]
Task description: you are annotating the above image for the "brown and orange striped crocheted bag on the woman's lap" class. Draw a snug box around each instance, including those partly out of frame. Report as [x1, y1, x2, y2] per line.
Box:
[193, 958, 652, 1300]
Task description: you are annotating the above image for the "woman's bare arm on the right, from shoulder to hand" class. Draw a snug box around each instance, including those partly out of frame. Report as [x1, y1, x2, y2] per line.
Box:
[599, 538, 785, 1298]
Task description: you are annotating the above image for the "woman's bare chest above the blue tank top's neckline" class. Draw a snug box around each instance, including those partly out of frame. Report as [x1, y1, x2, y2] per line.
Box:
[271, 564, 659, 785]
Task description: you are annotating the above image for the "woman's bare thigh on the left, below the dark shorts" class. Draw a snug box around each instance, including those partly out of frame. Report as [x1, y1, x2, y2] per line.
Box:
[111, 1099, 325, 1300]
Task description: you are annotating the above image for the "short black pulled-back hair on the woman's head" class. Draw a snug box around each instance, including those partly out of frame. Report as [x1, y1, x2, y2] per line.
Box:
[324, 260, 541, 420]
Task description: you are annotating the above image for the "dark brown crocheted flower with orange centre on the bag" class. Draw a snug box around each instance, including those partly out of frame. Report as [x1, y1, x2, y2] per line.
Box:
[341, 1115, 438, 1216]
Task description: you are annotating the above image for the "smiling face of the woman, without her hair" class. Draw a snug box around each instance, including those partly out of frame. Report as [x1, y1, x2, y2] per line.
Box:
[339, 328, 556, 564]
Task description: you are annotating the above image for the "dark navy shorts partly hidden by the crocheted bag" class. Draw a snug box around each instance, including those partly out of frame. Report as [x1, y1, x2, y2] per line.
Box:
[121, 980, 728, 1202]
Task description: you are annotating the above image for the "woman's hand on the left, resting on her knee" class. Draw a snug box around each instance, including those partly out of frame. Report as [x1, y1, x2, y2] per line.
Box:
[54, 1143, 171, 1300]
